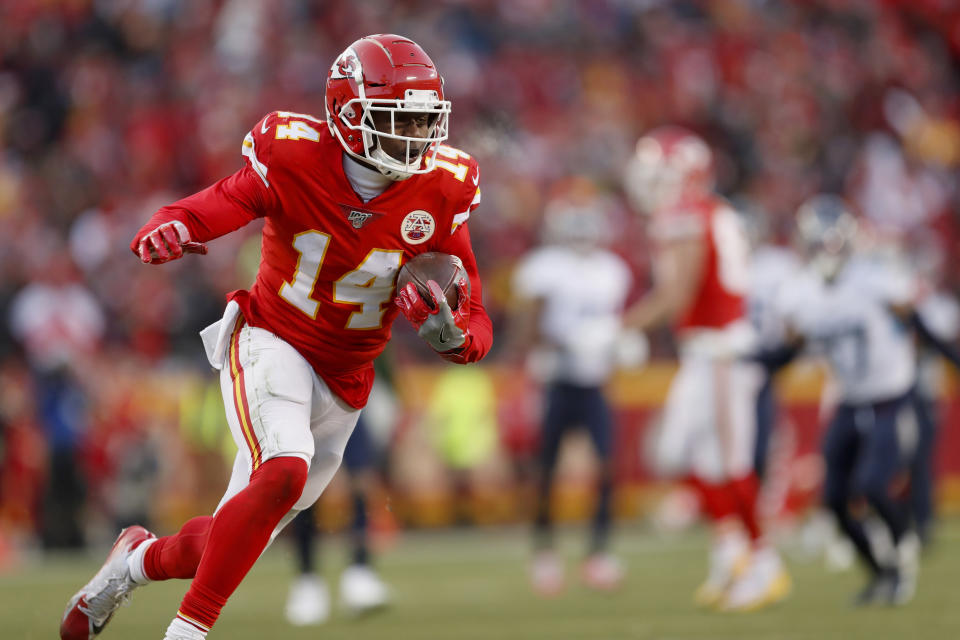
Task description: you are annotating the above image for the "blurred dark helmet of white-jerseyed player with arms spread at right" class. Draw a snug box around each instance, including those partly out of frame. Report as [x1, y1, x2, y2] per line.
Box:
[797, 194, 858, 280]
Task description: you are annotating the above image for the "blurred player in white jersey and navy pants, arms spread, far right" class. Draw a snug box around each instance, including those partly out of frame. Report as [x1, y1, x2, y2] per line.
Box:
[768, 194, 916, 605]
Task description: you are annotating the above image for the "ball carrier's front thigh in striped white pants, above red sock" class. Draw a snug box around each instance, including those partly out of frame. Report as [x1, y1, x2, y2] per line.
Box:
[220, 326, 316, 472]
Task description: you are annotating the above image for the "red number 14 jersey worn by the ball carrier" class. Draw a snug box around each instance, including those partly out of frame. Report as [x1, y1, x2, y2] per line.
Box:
[131, 111, 493, 408]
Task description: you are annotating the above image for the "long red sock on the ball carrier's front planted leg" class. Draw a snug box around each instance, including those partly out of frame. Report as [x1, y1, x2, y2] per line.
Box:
[177, 456, 307, 629]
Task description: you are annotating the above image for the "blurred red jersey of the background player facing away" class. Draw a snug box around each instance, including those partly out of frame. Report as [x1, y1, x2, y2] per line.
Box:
[652, 198, 750, 331]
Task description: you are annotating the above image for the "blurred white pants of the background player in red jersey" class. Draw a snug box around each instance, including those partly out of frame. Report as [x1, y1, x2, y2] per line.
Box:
[656, 355, 762, 483]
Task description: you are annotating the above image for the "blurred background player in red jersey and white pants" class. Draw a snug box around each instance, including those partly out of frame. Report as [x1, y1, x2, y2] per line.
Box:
[625, 127, 790, 611]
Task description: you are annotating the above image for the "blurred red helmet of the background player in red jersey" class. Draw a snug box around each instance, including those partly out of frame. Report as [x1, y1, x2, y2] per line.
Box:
[624, 126, 715, 214]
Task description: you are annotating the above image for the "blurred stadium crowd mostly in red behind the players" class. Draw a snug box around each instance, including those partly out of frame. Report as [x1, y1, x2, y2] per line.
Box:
[0, 0, 960, 565]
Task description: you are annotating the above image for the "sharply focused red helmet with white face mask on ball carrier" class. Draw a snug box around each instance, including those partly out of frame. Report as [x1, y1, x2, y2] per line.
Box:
[326, 34, 450, 180]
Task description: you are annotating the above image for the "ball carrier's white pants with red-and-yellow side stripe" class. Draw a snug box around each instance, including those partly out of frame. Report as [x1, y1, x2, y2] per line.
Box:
[200, 302, 360, 542]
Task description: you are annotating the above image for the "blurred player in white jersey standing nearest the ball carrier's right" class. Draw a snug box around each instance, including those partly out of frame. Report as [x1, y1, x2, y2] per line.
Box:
[513, 185, 632, 595]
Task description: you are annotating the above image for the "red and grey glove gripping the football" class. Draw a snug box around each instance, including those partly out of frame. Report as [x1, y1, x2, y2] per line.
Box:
[394, 278, 470, 353]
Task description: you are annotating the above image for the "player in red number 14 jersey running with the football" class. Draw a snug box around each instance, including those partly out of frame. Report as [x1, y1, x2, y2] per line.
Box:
[60, 34, 492, 640]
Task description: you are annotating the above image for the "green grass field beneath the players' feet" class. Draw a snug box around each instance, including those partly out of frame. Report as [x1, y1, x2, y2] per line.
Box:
[0, 521, 960, 640]
